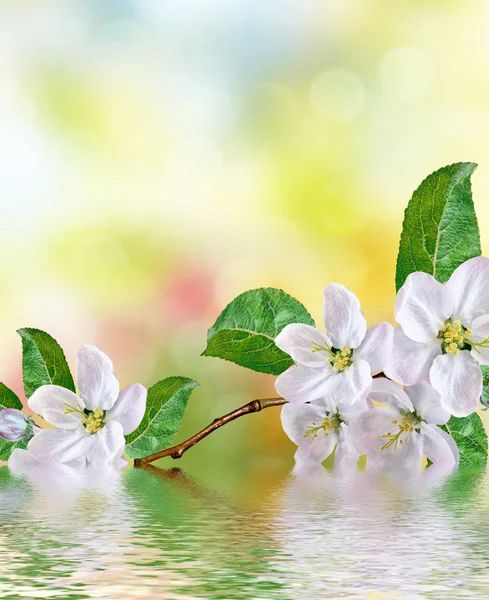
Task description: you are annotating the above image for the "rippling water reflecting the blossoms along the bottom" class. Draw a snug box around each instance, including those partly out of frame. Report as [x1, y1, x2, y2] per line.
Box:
[0, 468, 489, 600]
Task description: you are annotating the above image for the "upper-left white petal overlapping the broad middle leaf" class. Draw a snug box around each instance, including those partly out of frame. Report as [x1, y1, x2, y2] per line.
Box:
[275, 323, 331, 367]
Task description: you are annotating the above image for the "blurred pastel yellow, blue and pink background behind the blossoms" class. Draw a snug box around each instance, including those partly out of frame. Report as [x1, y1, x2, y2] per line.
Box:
[0, 0, 489, 481]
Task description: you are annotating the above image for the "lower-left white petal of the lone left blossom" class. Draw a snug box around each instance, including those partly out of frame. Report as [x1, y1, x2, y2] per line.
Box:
[27, 427, 88, 463]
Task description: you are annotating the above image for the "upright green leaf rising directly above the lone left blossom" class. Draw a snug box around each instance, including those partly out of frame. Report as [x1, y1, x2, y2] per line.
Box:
[17, 327, 75, 398]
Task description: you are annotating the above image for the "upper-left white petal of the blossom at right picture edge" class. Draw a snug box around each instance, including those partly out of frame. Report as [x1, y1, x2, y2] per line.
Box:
[394, 272, 453, 343]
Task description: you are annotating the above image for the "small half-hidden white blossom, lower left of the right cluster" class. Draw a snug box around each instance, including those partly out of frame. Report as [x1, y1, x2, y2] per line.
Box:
[282, 396, 368, 467]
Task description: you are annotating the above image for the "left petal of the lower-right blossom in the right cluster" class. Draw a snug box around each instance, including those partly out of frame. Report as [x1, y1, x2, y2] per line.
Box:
[348, 407, 399, 455]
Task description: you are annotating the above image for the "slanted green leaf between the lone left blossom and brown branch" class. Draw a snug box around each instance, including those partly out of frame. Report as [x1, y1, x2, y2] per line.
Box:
[126, 377, 199, 458]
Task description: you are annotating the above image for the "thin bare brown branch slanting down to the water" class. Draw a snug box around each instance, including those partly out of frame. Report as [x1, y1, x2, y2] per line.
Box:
[134, 398, 287, 467]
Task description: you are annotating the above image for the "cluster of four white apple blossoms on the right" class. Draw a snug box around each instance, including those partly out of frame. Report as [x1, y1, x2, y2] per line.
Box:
[275, 257, 489, 471]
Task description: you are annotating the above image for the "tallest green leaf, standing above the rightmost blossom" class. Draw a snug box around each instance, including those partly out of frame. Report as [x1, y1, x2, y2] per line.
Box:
[396, 163, 481, 290]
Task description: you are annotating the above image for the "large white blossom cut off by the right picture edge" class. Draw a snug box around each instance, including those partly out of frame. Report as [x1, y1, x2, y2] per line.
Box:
[384, 256, 489, 417]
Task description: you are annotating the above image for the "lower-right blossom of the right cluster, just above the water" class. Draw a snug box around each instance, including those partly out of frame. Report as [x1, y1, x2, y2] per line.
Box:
[349, 379, 459, 472]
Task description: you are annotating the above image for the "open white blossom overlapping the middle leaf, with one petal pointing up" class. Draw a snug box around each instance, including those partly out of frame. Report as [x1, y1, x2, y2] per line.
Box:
[275, 283, 393, 403]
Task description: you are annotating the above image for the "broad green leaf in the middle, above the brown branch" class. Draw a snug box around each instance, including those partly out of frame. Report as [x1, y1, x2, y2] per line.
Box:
[202, 288, 314, 375]
